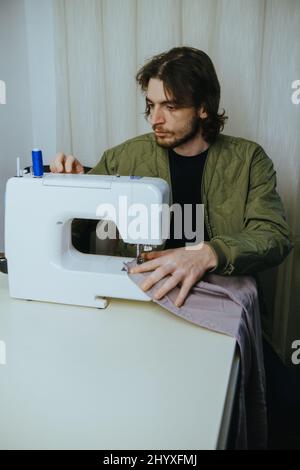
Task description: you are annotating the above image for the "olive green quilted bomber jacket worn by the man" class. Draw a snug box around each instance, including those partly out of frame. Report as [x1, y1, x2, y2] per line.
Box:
[90, 133, 293, 275]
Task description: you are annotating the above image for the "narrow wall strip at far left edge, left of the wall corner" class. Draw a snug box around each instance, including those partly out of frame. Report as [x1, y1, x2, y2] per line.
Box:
[0, 0, 32, 251]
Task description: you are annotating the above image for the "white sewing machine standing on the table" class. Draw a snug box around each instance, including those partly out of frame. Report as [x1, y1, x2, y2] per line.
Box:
[5, 174, 169, 308]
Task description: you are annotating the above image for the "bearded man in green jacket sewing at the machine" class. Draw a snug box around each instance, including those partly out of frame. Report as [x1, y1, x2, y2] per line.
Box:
[50, 47, 292, 307]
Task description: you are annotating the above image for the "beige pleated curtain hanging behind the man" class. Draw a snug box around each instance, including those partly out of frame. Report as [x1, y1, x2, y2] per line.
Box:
[53, 0, 300, 364]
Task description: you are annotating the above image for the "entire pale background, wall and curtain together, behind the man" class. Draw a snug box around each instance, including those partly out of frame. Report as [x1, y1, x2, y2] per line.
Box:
[0, 0, 300, 363]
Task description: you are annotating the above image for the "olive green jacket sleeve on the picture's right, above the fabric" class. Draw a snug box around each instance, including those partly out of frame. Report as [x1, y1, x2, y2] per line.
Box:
[209, 147, 293, 275]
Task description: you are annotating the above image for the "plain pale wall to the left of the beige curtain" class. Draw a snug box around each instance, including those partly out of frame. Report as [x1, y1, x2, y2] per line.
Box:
[0, 0, 56, 251]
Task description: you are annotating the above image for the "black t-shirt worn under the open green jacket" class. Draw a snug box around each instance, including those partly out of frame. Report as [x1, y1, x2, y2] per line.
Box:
[166, 149, 209, 249]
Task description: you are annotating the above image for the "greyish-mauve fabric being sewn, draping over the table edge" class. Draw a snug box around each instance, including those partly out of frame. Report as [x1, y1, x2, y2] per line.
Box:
[126, 261, 267, 449]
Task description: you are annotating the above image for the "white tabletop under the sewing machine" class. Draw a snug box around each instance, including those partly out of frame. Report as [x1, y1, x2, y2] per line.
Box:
[0, 273, 238, 450]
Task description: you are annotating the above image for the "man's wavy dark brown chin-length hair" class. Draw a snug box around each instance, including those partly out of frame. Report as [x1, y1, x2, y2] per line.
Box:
[136, 46, 227, 143]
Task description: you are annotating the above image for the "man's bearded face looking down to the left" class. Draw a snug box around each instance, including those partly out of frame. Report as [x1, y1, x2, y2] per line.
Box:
[146, 78, 207, 148]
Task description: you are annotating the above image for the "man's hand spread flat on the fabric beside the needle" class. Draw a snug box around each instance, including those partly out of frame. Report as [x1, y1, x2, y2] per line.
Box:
[129, 243, 217, 307]
